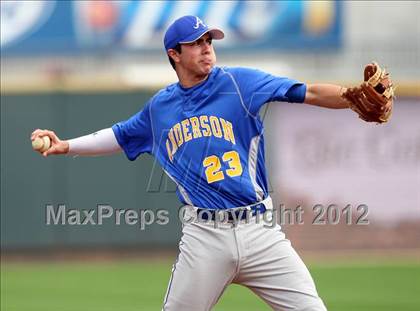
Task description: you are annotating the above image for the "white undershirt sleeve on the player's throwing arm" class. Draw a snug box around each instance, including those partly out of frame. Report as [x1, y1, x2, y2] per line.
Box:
[68, 128, 122, 156]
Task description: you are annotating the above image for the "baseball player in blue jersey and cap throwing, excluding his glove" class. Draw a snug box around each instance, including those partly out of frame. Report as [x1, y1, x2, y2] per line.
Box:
[32, 16, 390, 311]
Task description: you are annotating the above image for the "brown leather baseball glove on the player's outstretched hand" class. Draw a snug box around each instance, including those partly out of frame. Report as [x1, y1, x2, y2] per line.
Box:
[341, 62, 394, 123]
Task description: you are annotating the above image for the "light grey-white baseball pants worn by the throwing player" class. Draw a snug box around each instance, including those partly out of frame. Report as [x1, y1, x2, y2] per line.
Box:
[162, 199, 326, 311]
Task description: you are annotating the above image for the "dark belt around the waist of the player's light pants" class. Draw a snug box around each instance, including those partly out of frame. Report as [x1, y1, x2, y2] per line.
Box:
[197, 203, 267, 221]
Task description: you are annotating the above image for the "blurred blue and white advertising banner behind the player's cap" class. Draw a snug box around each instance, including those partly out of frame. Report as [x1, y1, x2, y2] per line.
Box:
[1, 0, 341, 55]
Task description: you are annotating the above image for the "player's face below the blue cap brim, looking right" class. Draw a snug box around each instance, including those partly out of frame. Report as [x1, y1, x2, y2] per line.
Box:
[179, 33, 216, 76]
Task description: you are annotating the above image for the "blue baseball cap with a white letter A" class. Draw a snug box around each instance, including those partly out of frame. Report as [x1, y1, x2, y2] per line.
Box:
[163, 15, 225, 51]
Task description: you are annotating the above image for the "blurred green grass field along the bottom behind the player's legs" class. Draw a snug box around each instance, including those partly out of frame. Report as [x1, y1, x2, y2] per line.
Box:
[1, 260, 420, 311]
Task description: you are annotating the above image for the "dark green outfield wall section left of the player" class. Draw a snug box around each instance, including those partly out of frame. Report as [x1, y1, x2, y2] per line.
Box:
[1, 91, 181, 250]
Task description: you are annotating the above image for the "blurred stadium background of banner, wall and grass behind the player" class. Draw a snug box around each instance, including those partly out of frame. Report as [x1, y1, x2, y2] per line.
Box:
[0, 1, 420, 310]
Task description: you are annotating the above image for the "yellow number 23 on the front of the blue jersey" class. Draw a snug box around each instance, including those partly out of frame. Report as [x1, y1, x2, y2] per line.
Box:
[203, 151, 243, 184]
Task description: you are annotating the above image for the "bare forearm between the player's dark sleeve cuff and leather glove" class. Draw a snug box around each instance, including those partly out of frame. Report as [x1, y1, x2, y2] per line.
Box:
[305, 84, 349, 109]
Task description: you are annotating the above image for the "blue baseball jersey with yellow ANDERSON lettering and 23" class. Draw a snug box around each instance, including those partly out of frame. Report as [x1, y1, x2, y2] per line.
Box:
[112, 67, 306, 209]
